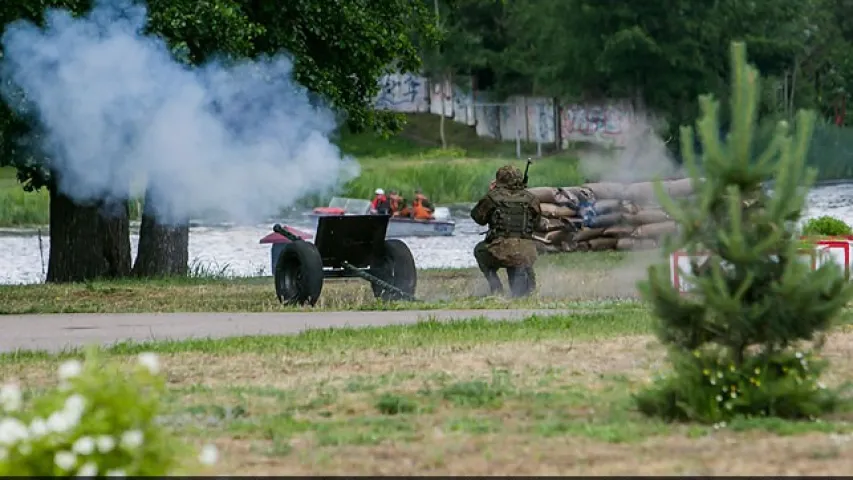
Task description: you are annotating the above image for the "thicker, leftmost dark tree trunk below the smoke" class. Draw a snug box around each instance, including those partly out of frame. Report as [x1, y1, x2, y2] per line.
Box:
[45, 189, 130, 283]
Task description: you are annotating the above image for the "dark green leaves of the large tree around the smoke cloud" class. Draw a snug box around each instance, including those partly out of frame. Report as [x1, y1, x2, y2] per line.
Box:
[0, 0, 439, 190]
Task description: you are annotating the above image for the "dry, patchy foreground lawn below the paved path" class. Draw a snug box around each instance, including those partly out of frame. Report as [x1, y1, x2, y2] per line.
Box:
[5, 307, 853, 475]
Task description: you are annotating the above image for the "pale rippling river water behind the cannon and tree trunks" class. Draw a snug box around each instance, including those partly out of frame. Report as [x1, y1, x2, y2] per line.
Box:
[5, 183, 853, 284]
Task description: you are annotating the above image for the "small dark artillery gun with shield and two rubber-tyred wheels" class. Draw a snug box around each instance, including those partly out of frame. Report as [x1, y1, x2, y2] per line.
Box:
[273, 215, 418, 306]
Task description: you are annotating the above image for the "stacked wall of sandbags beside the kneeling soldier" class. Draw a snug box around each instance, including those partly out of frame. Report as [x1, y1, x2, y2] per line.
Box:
[528, 178, 693, 253]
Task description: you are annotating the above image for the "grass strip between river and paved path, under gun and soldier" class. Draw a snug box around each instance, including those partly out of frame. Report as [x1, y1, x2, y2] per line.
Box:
[0, 252, 644, 321]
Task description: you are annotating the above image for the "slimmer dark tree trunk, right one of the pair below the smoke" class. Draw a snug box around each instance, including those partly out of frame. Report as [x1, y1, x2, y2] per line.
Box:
[133, 190, 190, 277]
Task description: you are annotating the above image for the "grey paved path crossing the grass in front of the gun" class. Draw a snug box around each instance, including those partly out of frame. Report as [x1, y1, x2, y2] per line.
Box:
[0, 310, 588, 352]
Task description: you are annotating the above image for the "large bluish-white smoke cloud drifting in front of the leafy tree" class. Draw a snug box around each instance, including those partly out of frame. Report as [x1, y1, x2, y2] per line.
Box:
[0, 0, 359, 222]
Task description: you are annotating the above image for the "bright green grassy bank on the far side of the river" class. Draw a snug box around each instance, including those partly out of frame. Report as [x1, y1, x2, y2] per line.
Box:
[0, 114, 580, 227]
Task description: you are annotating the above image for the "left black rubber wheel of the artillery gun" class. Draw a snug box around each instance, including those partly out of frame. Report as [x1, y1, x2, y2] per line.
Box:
[275, 240, 323, 307]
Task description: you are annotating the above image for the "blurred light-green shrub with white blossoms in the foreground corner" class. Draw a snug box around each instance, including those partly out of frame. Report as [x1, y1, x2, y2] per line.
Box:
[0, 351, 216, 476]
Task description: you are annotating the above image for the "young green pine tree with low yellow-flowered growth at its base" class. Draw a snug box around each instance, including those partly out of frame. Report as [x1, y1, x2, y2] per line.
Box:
[640, 43, 853, 421]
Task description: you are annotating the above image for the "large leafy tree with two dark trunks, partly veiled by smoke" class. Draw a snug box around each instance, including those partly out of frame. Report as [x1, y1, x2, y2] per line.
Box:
[0, 0, 437, 282]
